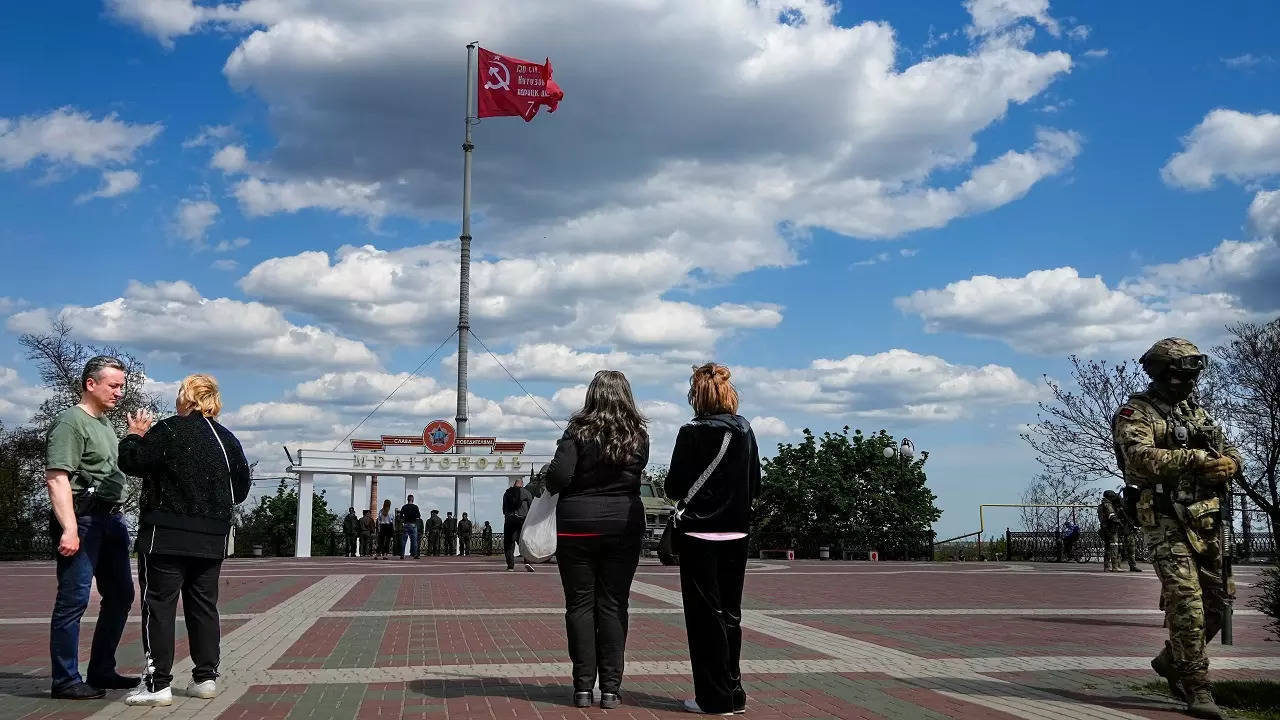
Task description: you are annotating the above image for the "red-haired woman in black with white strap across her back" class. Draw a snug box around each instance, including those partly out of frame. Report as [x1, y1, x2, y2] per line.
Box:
[666, 363, 760, 715]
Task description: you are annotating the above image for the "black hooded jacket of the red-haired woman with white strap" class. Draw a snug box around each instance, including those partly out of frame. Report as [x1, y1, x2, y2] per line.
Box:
[666, 414, 760, 533]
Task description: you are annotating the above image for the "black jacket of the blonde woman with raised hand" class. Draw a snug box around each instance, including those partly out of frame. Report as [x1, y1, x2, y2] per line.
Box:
[120, 410, 250, 534]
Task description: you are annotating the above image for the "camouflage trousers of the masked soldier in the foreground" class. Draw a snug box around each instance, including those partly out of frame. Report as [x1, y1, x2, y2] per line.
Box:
[1143, 515, 1235, 691]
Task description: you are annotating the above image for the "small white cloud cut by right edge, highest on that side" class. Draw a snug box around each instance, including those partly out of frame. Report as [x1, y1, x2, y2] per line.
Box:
[1160, 109, 1280, 190]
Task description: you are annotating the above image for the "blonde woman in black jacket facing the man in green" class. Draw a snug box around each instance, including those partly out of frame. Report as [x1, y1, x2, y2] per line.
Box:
[120, 375, 250, 706]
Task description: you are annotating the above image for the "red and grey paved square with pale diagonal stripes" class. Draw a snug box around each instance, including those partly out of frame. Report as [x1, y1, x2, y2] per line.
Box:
[0, 557, 1280, 720]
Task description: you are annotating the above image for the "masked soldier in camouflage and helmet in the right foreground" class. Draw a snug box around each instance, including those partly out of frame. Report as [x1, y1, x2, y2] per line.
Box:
[1111, 338, 1242, 717]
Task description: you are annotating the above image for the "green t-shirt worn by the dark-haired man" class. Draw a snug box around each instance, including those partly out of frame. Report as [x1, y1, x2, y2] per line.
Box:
[45, 405, 127, 502]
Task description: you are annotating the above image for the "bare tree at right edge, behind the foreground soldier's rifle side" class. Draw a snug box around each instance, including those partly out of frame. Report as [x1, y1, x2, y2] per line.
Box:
[1202, 319, 1280, 527]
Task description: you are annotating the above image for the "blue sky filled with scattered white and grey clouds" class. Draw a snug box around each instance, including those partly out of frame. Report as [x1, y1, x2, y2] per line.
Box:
[0, 0, 1280, 534]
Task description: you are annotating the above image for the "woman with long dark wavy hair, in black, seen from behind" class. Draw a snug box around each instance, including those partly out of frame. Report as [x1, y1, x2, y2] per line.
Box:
[547, 370, 649, 708]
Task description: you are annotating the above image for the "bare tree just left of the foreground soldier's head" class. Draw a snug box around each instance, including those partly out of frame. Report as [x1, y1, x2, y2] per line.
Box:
[1021, 355, 1147, 481]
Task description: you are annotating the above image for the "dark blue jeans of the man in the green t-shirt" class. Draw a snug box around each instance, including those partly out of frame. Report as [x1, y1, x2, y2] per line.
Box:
[49, 512, 133, 691]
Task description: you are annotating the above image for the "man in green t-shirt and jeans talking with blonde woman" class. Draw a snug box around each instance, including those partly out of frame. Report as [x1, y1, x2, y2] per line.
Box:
[45, 355, 138, 700]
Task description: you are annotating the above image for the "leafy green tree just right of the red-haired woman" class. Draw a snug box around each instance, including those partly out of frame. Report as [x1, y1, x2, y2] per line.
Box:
[756, 425, 942, 557]
